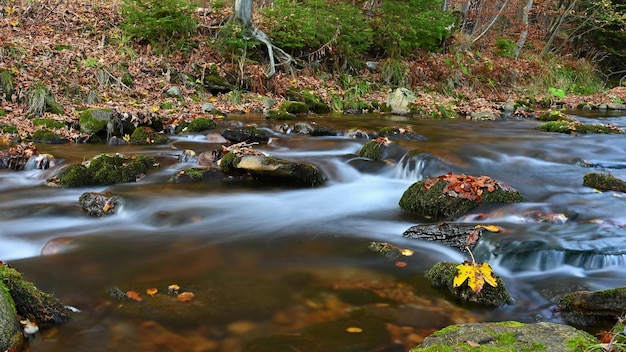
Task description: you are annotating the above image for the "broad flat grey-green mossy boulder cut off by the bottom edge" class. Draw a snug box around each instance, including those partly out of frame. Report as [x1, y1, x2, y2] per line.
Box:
[410, 321, 599, 352]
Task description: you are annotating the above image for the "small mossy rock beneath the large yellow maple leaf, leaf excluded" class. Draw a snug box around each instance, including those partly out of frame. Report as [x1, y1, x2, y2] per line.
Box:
[426, 262, 513, 307]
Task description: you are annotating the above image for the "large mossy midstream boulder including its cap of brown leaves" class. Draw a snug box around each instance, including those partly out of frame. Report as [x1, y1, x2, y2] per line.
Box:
[399, 173, 524, 221]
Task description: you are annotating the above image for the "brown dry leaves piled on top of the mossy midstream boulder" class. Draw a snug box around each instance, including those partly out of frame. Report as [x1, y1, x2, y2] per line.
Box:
[424, 172, 501, 203]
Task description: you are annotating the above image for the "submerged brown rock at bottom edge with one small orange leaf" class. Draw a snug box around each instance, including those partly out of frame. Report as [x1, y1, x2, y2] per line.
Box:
[244, 310, 392, 352]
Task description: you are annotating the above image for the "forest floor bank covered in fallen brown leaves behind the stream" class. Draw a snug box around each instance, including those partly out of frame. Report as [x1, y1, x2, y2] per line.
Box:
[0, 0, 626, 142]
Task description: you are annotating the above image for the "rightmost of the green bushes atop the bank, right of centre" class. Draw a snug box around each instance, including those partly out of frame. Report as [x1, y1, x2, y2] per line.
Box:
[371, 0, 456, 57]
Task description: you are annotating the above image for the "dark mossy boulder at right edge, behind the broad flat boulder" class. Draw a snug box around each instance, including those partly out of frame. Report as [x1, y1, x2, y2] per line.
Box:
[558, 287, 626, 326]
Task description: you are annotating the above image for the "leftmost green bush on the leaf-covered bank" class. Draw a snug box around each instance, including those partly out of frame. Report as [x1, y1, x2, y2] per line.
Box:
[120, 0, 197, 49]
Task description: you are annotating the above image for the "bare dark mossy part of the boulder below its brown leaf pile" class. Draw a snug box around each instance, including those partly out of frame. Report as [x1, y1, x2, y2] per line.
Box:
[399, 179, 525, 221]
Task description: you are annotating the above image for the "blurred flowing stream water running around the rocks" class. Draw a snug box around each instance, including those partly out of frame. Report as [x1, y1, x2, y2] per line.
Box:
[0, 112, 626, 351]
